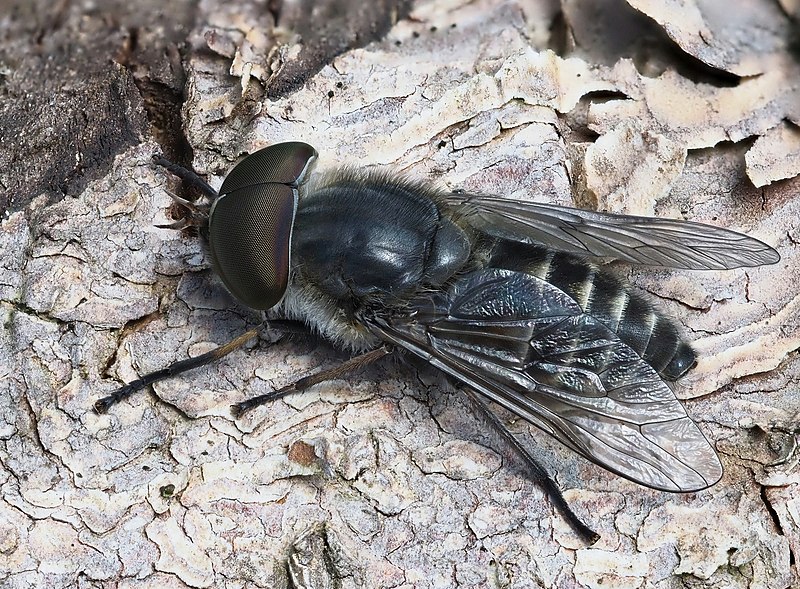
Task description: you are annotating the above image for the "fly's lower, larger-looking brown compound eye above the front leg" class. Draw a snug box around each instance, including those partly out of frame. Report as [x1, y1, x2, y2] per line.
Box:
[208, 183, 298, 309]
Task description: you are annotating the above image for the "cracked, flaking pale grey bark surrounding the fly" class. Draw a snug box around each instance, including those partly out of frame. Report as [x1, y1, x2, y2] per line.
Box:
[0, 0, 800, 589]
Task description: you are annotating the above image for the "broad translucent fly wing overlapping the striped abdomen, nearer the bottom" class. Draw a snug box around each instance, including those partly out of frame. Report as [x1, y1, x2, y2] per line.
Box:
[368, 269, 722, 492]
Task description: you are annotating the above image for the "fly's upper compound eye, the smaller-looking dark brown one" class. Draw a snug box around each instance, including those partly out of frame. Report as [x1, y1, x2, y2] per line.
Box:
[219, 141, 317, 194]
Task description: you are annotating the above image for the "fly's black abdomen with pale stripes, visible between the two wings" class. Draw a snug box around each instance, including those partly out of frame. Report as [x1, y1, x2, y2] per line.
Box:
[488, 242, 695, 380]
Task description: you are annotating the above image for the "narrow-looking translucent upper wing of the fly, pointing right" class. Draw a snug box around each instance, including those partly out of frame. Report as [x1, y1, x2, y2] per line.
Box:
[445, 194, 780, 270]
